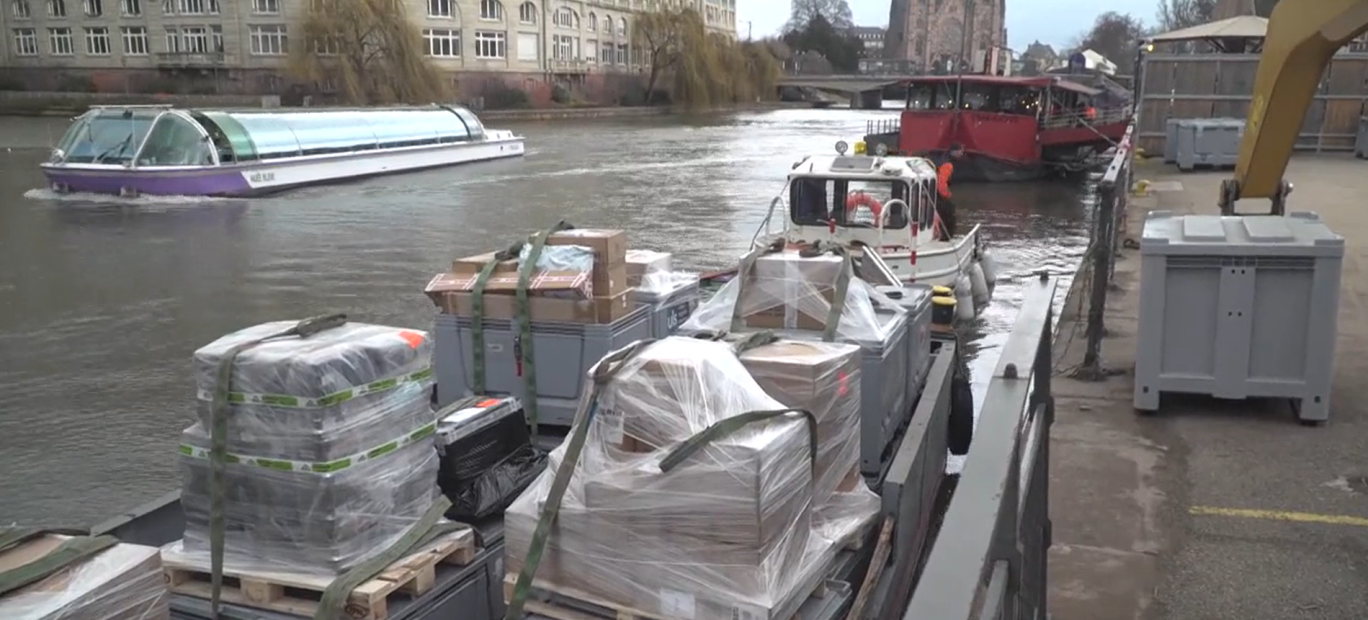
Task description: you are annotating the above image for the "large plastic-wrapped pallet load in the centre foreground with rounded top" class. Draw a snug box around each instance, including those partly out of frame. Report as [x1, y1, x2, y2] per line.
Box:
[505, 338, 834, 620]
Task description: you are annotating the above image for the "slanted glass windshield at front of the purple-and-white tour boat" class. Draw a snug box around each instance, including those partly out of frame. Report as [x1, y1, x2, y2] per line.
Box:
[57, 108, 163, 164]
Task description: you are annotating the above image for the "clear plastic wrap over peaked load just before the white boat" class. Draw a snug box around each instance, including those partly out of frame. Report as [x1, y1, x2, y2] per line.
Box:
[681, 252, 907, 342]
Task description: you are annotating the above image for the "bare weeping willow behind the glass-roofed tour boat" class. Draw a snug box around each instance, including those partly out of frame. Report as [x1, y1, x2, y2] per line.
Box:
[290, 0, 449, 105]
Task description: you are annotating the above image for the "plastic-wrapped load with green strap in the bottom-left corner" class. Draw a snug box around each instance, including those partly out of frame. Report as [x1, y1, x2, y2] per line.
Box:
[0, 535, 171, 620]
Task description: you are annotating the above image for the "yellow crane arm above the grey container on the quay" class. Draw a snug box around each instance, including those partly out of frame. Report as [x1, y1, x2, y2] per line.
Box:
[1220, 0, 1368, 214]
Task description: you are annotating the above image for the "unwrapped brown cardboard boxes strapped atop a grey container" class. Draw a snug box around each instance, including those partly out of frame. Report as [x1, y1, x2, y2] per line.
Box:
[425, 229, 635, 323]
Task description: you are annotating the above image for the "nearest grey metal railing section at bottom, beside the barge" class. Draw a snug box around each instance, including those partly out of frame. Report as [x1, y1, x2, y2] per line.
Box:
[903, 274, 1056, 620]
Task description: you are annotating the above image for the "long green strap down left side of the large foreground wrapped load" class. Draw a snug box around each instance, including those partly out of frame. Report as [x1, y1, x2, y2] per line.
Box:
[503, 339, 654, 620]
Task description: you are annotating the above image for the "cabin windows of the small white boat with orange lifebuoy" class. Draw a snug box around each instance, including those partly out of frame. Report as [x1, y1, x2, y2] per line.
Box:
[788, 178, 911, 230]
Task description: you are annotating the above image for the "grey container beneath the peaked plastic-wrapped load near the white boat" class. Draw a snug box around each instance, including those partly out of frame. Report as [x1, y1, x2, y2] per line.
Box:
[773, 311, 911, 474]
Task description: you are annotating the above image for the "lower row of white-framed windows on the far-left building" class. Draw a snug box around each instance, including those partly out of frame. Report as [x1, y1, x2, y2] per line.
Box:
[14, 25, 289, 56]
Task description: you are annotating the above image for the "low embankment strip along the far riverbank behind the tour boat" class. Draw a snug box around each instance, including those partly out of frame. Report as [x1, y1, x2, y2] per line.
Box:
[0, 90, 810, 122]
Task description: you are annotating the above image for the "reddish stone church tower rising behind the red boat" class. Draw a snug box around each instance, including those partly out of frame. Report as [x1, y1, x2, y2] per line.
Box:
[885, 0, 1007, 73]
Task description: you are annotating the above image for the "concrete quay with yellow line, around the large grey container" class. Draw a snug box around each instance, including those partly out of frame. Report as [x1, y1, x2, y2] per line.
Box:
[1049, 156, 1368, 620]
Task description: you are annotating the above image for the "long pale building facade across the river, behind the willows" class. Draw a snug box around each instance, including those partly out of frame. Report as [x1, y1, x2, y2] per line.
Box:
[0, 0, 736, 93]
